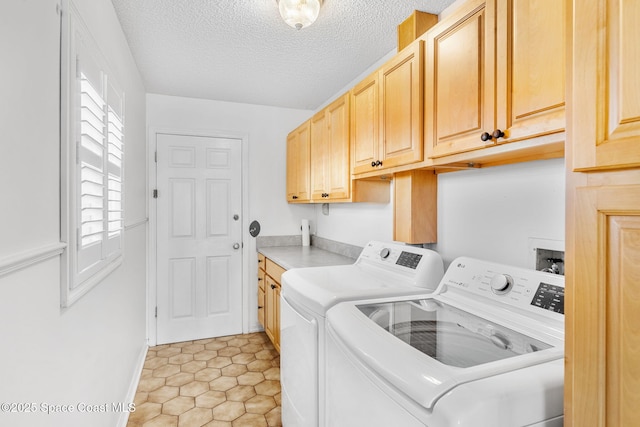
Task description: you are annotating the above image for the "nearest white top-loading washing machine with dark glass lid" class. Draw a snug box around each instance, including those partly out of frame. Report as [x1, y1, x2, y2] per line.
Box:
[323, 257, 564, 427]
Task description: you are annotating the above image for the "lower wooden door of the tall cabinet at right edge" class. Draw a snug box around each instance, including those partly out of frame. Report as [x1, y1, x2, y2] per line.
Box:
[565, 185, 640, 427]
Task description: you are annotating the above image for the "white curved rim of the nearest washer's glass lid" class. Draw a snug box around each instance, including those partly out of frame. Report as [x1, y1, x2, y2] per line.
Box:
[327, 296, 563, 409]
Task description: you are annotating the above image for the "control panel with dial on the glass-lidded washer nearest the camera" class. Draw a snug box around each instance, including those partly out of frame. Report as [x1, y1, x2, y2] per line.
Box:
[441, 257, 564, 315]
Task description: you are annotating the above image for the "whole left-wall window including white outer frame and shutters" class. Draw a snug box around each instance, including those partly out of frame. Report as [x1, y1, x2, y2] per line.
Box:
[61, 4, 124, 307]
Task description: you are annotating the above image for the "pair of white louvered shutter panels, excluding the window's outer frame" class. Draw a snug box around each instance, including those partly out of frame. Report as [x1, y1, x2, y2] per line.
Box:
[74, 35, 124, 286]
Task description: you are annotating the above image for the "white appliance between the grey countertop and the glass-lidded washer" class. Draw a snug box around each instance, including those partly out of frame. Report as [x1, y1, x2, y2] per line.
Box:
[280, 241, 444, 427]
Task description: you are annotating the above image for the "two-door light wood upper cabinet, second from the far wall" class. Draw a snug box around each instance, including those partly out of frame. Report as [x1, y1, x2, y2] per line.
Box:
[311, 94, 351, 202]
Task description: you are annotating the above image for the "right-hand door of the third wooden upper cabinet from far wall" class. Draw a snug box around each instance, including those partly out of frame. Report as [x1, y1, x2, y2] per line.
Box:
[379, 40, 424, 168]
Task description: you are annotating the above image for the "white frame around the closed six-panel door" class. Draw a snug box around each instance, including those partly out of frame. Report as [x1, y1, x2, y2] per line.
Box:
[146, 127, 250, 346]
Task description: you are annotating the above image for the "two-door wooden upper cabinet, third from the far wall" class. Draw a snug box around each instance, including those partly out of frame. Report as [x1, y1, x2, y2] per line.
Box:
[351, 40, 424, 175]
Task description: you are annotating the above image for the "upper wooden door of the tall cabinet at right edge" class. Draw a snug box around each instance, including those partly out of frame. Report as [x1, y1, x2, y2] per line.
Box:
[572, 0, 640, 170]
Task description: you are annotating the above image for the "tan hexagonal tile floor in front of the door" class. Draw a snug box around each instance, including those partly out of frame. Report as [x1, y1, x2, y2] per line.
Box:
[127, 332, 282, 427]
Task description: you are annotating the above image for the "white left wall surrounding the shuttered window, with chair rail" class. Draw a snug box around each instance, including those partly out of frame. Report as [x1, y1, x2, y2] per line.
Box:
[0, 0, 147, 427]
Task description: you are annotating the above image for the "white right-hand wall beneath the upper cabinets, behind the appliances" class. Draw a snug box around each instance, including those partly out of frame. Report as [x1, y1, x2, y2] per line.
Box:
[315, 159, 565, 268]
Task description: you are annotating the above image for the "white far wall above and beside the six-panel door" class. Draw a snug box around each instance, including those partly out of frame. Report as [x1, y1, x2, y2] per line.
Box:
[147, 94, 314, 331]
